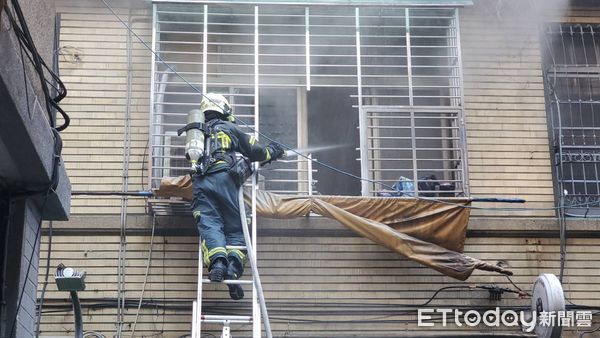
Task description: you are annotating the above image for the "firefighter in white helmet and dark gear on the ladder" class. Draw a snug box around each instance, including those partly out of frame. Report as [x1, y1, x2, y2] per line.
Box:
[192, 93, 284, 299]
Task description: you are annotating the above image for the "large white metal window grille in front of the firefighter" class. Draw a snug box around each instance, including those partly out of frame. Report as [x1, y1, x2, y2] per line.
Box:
[150, 2, 466, 209]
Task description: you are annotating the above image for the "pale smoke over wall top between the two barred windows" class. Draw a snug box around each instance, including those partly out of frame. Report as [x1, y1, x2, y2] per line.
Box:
[460, 0, 570, 80]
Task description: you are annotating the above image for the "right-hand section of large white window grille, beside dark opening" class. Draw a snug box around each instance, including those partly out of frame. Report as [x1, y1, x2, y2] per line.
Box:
[357, 8, 467, 197]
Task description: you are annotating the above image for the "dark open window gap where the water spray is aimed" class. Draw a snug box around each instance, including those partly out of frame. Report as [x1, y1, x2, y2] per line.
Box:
[307, 87, 360, 196]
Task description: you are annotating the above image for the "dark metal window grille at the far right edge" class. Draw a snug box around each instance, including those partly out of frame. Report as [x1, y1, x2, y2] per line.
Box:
[544, 24, 600, 216]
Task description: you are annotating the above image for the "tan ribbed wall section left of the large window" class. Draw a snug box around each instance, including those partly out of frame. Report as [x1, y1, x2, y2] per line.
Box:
[56, 0, 151, 214]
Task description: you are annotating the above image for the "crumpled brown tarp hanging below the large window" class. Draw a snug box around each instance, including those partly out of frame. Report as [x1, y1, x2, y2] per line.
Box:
[155, 175, 512, 280]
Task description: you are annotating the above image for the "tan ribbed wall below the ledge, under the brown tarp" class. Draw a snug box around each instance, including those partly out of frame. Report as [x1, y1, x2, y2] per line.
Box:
[40, 226, 600, 337]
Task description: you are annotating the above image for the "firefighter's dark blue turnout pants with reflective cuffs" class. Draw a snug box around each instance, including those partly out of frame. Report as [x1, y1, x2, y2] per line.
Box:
[192, 170, 246, 268]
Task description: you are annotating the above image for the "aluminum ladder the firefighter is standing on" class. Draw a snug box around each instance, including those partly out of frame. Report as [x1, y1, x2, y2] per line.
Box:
[192, 184, 273, 338]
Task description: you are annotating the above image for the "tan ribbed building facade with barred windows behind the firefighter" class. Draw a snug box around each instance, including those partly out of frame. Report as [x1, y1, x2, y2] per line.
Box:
[39, 0, 600, 337]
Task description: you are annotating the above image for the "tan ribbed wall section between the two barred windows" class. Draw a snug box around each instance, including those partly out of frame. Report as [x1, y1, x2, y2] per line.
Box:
[460, 2, 554, 216]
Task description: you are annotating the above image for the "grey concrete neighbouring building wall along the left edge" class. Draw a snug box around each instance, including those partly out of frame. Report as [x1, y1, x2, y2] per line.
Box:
[0, 0, 70, 337]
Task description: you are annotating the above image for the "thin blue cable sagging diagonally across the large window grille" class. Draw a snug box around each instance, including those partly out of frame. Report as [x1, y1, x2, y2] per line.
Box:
[101, 0, 600, 212]
